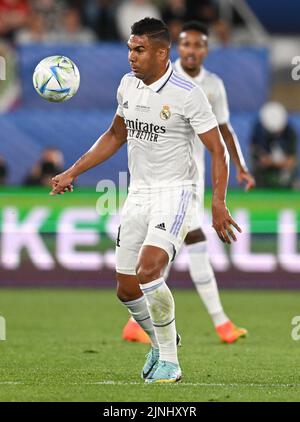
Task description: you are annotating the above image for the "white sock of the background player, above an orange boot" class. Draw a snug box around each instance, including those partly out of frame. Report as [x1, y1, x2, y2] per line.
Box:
[187, 241, 229, 326]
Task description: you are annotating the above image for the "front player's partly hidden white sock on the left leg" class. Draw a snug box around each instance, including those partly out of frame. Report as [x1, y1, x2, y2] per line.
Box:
[122, 296, 158, 349]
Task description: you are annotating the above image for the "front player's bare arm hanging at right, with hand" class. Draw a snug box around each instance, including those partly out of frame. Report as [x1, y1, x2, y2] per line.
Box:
[199, 127, 242, 244]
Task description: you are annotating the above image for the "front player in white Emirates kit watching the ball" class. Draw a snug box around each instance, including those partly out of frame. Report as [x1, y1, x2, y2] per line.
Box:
[51, 18, 241, 383]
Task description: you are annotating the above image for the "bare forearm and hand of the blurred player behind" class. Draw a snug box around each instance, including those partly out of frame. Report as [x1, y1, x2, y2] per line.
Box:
[219, 123, 255, 191]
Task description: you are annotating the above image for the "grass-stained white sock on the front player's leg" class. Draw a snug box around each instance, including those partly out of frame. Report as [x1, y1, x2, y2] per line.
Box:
[140, 277, 178, 364]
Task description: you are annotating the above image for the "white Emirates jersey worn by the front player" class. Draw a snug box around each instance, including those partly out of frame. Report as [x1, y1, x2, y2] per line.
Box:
[117, 63, 218, 190]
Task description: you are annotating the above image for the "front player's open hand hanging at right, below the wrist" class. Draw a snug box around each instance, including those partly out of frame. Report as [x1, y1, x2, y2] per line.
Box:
[212, 198, 242, 244]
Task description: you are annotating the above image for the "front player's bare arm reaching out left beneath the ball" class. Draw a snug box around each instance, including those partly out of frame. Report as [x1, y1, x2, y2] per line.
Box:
[50, 115, 127, 195]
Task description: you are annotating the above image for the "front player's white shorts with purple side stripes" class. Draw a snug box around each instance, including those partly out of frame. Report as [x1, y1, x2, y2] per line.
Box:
[116, 186, 195, 275]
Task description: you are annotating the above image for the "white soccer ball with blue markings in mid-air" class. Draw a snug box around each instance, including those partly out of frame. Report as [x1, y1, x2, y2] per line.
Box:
[33, 56, 80, 102]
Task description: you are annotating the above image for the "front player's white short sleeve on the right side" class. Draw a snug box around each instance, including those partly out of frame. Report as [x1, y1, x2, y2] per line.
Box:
[184, 87, 218, 134]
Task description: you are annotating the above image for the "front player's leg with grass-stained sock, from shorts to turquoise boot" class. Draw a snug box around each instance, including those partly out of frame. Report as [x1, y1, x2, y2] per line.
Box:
[137, 187, 193, 382]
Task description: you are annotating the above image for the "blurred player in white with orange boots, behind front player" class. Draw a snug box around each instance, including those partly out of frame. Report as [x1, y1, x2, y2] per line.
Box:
[123, 21, 255, 343]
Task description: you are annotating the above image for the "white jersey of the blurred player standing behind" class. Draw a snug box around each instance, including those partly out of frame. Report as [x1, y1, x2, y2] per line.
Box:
[173, 59, 229, 181]
